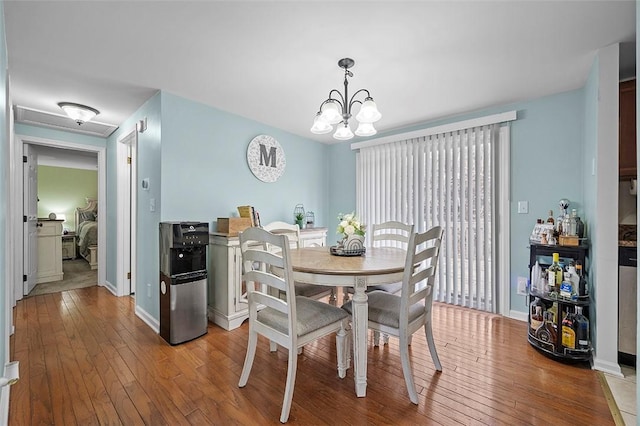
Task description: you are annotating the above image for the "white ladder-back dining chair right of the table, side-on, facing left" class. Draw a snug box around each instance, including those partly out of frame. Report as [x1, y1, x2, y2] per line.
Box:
[342, 226, 444, 404]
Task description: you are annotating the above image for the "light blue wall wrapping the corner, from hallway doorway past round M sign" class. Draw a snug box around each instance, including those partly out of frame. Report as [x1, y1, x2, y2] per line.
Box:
[115, 92, 329, 319]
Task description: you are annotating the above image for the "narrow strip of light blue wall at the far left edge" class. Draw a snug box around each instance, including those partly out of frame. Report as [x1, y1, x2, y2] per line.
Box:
[0, 2, 11, 371]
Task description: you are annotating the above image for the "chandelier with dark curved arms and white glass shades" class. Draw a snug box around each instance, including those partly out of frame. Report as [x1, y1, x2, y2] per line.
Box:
[311, 58, 382, 141]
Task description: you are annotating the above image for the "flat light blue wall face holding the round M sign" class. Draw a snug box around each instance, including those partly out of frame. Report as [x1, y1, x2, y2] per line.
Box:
[161, 92, 329, 226]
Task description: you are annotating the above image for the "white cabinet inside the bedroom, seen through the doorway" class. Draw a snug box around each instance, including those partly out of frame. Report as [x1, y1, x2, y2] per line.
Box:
[36, 220, 64, 283]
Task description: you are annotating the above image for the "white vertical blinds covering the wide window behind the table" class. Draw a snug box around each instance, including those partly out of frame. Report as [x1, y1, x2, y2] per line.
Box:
[356, 124, 499, 312]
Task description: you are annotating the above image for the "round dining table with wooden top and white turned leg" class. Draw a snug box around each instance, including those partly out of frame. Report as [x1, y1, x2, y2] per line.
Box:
[291, 247, 406, 397]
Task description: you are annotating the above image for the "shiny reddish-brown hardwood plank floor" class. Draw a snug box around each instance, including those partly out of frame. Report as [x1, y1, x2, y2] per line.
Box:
[9, 287, 614, 425]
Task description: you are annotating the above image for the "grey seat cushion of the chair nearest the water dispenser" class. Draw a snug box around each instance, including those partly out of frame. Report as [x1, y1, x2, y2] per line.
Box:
[258, 296, 349, 336]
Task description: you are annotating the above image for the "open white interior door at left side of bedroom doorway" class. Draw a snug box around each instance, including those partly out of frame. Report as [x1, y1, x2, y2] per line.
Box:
[23, 144, 38, 296]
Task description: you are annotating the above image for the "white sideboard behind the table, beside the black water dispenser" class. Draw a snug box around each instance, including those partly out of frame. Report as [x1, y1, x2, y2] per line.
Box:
[207, 228, 327, 330]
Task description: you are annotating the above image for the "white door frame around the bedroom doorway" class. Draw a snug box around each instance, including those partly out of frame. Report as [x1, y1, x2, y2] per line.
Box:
[9, 135, 109, 301]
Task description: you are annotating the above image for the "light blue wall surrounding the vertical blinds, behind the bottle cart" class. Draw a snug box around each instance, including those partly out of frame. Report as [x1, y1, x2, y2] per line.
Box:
[328, 89, 584, 314]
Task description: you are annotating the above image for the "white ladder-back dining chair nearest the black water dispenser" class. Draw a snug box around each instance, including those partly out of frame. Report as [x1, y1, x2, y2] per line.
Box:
[238, 227, 349, 423]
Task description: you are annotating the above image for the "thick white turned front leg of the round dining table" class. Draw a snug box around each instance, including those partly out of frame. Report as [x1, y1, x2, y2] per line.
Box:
[352, 277, 369, 397]
